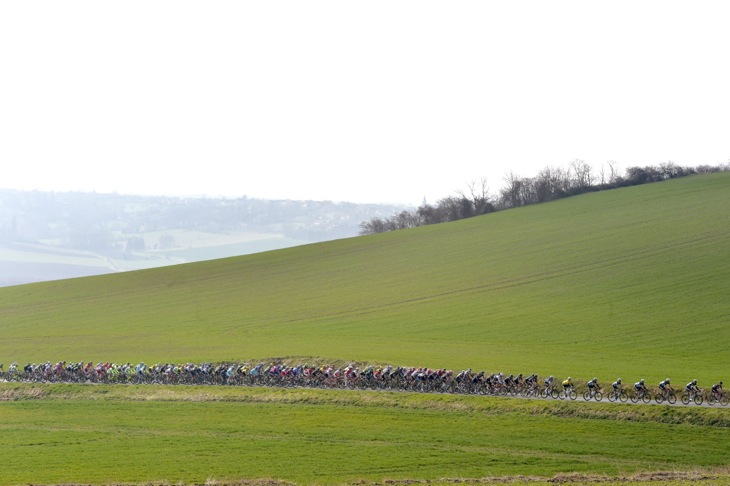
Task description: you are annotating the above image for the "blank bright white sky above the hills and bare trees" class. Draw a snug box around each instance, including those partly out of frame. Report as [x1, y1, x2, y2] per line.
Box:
[0, 0, 730, 205]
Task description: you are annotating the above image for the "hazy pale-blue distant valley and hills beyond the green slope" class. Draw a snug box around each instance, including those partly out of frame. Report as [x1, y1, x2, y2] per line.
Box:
[0, 189, 404, 286]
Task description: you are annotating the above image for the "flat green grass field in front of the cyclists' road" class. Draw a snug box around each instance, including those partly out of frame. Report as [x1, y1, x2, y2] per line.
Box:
[0, 384, 730, 484]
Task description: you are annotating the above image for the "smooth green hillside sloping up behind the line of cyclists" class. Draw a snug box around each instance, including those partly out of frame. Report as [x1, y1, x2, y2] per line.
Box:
[0, 173, 730, 384]
